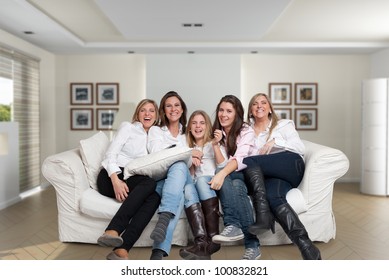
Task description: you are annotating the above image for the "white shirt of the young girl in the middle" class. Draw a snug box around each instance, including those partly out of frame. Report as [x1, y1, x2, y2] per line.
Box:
[194, 142, 227, 178]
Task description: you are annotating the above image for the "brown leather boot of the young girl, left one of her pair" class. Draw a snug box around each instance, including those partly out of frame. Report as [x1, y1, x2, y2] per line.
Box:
[180, 203, 211, 260]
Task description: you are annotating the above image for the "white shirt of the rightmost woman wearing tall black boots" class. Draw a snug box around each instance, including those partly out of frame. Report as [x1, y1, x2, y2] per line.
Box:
[255, 119, 305, 157]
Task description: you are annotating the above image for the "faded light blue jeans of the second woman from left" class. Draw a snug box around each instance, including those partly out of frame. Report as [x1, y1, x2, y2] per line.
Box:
[153, 161, 194, 255]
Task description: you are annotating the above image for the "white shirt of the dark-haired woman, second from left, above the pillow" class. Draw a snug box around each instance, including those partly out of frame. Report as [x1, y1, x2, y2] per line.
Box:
[147, 124, 188, 153]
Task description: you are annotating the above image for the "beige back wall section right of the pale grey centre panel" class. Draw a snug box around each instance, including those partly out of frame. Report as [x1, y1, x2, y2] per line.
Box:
[242, 55, 369, 181]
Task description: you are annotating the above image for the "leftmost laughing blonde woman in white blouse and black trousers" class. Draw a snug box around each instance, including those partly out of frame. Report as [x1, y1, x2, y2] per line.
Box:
[97, 99, 160, 260]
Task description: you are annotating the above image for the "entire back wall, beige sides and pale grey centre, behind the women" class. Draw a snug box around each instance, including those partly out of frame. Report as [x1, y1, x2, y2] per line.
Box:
[0, 27, 372, 181]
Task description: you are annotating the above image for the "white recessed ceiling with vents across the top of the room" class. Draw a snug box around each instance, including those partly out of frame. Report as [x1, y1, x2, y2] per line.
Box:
[0, 0, 389, 54]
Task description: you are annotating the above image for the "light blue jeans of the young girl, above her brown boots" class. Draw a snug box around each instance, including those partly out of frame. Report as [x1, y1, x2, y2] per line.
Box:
[184, 176, 216, 208]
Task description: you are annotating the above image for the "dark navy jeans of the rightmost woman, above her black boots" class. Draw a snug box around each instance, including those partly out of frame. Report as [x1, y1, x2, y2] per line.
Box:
[243, 151, 305, 210]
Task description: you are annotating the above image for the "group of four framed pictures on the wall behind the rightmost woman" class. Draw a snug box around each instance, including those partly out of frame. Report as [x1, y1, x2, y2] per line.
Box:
[269, 83, 318, 130]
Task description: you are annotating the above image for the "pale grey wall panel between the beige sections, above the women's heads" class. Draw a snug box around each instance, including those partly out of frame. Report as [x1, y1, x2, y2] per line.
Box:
[146, 54, 241, 120]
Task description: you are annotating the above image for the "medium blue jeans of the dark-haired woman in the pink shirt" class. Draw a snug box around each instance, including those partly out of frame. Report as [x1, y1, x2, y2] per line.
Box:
[217, 172, 259, 248]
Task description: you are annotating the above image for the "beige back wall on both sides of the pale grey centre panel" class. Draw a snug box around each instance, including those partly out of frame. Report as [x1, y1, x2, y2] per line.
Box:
[0, 30, 371, 184]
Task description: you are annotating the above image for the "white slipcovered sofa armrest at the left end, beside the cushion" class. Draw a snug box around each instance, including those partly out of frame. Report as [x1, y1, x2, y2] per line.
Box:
[42, 149, 89, 213]
